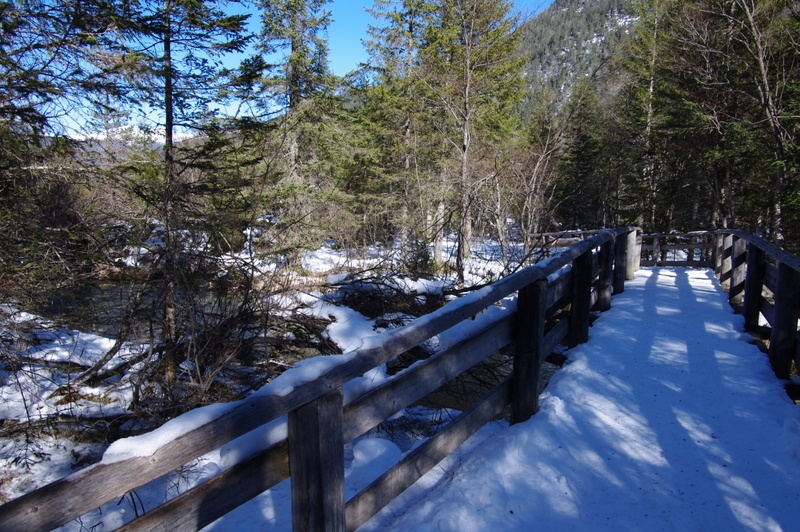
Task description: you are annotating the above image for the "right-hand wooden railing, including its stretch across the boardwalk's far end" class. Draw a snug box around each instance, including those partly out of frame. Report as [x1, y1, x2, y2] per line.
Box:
[639, 229, 800, 379]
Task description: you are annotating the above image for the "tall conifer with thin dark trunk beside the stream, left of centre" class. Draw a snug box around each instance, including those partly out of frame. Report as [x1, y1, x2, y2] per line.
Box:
[106, 0, 248, 388]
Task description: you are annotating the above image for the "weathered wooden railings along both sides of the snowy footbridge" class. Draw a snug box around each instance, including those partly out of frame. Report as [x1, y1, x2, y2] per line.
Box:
[0, 227, 800, 531]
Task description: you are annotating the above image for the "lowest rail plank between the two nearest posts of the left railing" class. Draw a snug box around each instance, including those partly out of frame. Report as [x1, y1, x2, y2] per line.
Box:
[347, 379, 510, 532]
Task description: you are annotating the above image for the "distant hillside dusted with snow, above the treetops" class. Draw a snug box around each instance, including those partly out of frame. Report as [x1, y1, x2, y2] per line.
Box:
[522, 0, 634, 110]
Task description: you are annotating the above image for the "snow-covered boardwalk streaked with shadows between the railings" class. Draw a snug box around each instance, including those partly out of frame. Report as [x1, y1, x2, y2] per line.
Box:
[363, 268, 800, 532]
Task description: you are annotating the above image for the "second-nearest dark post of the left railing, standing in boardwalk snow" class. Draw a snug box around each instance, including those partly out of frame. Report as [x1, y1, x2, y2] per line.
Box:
[511, 279, 548, 424]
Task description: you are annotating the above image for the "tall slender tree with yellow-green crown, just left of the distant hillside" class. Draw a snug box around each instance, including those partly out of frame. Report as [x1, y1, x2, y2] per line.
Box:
[420, 0, 522, 283]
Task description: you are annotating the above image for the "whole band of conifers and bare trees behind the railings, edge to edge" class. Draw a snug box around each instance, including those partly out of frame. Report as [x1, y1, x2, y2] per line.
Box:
[0, 0, 800, 408]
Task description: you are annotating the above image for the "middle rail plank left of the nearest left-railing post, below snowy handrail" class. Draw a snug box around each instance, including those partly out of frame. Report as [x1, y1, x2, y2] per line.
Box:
[116, 440, 289, 532]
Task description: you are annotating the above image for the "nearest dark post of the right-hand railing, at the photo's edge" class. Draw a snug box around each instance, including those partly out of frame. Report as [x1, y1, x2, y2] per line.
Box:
[769, 263, 800, 379]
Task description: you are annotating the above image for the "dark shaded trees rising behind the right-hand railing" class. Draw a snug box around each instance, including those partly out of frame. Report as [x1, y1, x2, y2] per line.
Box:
[561, 0, 800, 247]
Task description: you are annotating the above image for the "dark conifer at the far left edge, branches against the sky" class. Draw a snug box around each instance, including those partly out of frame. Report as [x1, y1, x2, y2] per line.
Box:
[0, 0, 138, 297]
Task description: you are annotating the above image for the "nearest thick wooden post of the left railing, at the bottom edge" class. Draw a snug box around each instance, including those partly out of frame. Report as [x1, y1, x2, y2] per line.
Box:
[289, 388, 345, 532]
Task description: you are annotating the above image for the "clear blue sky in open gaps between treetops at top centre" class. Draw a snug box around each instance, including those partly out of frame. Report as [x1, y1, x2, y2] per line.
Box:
[328, 0, 552, 76]
